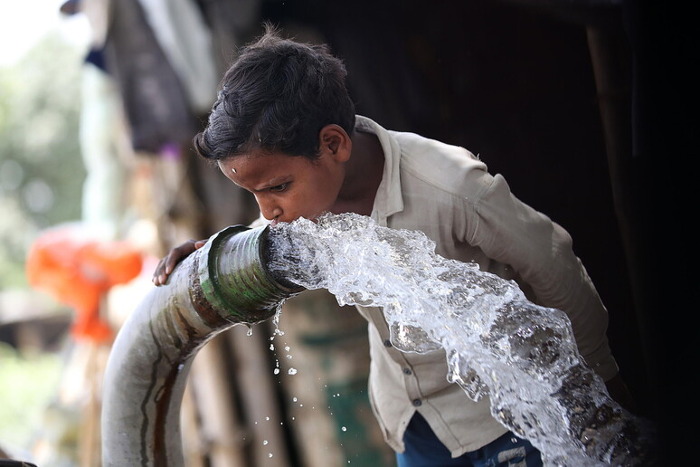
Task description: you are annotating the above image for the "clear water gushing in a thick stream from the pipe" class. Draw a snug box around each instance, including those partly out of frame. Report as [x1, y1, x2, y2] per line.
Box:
[269, 214, 654, 466]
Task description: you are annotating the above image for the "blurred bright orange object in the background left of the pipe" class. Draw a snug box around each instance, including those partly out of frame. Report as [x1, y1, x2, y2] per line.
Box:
[26, 225, 143, 342]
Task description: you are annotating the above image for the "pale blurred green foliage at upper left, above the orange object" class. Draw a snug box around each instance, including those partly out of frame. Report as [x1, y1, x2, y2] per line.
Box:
[0, 30, 85, 289]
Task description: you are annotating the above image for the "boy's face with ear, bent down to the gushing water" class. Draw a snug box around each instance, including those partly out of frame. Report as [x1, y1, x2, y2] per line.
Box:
[218, 150, 345, 225]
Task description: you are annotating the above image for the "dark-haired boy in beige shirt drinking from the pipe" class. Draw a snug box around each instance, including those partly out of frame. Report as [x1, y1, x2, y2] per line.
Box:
[153, 28, 626, 467]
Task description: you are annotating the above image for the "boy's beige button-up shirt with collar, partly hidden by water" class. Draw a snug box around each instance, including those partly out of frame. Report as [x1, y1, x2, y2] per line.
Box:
[356, 116, 618, 457]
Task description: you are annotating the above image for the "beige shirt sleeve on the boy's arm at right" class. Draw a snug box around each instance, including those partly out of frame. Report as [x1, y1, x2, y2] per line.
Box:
[466, 171, 618, 380]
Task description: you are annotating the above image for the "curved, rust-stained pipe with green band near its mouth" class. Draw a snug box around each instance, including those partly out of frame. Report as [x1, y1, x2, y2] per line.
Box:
[101, 225, 303, 467]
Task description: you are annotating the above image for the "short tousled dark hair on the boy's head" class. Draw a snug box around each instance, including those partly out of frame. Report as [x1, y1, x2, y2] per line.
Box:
[193, 25, 355, 161]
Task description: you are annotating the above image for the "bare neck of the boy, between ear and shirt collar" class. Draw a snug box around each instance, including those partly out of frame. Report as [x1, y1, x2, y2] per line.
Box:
[333, 131, 384, 216]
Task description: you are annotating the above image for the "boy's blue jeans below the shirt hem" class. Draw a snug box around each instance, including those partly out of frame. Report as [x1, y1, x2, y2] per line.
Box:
[396, 412, 542, 467]
